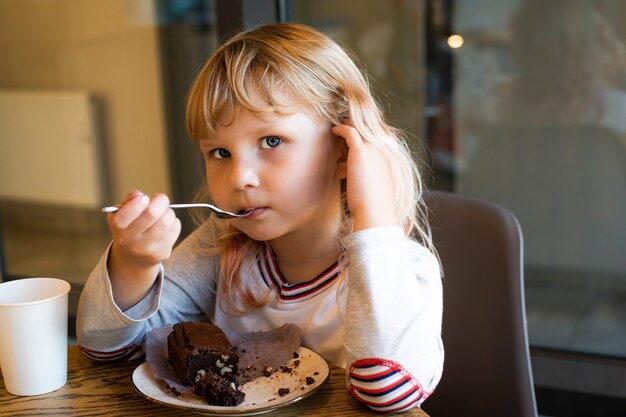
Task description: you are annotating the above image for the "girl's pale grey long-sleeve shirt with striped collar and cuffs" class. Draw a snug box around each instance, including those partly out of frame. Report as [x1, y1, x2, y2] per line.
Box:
[77, 226, 443, 411]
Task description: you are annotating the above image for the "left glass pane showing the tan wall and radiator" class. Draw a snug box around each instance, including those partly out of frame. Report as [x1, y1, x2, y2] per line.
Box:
[0, 0, 217, 328]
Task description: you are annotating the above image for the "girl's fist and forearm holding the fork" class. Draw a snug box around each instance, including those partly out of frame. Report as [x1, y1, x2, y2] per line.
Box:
[107, 191, 180, 310]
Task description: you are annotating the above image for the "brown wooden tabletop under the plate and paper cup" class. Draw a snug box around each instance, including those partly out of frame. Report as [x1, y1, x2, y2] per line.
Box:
[0, 346, 428, 417]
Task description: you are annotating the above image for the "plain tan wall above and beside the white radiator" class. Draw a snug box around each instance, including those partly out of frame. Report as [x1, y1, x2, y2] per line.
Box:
[0, 0, 170, 201]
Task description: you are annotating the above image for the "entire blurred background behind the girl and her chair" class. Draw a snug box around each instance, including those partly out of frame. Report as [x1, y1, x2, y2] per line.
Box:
[0, 0, 626, 416]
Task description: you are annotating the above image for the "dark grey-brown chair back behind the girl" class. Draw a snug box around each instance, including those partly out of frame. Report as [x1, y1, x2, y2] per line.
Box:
[423, 191, 537, 417]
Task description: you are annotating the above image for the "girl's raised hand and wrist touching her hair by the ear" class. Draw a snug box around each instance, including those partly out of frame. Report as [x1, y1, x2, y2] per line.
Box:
[332, 124, 399, 231]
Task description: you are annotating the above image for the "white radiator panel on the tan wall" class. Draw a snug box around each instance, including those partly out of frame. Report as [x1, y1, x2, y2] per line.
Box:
[0, 90, 104, 208]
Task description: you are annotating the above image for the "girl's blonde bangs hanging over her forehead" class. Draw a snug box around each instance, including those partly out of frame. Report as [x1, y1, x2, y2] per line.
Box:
[187, 33, 345, 142]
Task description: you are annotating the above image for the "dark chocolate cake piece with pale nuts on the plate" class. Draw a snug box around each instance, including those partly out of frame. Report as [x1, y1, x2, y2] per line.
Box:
[167, 322, 245, 405]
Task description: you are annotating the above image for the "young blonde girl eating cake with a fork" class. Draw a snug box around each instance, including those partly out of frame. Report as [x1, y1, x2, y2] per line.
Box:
[78, 24, 443, 411]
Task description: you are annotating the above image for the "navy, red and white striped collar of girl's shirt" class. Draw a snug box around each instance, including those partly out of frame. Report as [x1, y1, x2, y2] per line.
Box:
[258, 245, 348, 303]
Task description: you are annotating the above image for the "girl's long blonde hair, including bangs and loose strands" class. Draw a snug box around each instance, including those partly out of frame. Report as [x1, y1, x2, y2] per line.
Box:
[187, 23, 434, 314]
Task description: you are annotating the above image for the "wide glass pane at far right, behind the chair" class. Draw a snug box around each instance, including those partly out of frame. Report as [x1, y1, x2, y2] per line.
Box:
[453, 0, 626, 357]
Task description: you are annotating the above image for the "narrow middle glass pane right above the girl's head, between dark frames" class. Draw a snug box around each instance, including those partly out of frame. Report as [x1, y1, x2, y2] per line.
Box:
[291, 0, 426, 160]
